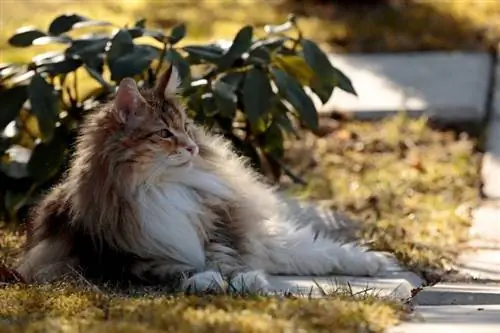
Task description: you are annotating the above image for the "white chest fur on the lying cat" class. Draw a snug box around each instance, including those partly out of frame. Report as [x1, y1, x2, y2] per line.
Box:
[137, 169, 231, 268]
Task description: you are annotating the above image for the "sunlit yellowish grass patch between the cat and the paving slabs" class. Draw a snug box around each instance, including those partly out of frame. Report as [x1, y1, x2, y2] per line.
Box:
[286, 114, 481, 273]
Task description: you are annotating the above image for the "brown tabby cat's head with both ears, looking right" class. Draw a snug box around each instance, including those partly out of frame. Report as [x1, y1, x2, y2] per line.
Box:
[107, 67, 199, 172]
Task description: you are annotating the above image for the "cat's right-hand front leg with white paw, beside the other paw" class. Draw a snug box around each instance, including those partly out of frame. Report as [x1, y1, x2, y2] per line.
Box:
[206, 243, 269, 293]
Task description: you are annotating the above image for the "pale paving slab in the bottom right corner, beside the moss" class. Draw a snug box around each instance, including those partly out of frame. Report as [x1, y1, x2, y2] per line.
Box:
[387, 305, 500, 333]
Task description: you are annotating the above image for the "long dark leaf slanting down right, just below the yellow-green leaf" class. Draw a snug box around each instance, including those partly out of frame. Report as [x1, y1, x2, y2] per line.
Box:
[271, 67, 318, 130]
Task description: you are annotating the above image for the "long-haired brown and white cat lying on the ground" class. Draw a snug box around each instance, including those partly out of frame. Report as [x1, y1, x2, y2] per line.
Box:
[17, 65, 384, 292]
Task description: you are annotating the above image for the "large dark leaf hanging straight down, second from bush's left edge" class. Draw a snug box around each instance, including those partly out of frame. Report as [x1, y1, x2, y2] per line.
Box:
[28, 73, 59, 141]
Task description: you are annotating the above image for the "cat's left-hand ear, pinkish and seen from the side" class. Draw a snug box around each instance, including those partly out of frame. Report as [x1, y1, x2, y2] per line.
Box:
[113, 78, 146, 125]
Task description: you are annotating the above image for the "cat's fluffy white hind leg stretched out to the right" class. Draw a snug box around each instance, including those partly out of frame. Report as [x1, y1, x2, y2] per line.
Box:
[244, 222, 385, 276]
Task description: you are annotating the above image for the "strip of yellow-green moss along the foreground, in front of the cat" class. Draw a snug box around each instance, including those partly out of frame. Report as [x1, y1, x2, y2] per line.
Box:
[0, 284, 402, 332]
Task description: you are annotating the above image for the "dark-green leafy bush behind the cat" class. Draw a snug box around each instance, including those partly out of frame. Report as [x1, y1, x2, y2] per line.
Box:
[0, 14, 355, 224]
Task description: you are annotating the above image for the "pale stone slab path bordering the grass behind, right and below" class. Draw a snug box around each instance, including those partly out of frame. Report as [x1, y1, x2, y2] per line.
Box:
[272, 52, 500, 333]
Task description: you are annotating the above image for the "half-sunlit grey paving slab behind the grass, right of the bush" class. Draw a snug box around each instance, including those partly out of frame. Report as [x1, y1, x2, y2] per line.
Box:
[316, 52, 492, 123]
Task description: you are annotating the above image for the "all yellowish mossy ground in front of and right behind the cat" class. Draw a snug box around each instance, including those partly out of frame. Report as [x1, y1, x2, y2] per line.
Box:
[0, 115, 480, 333]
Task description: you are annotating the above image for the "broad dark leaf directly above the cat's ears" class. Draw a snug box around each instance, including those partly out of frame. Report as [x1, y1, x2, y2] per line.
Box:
[108, 45, 159, 82]
